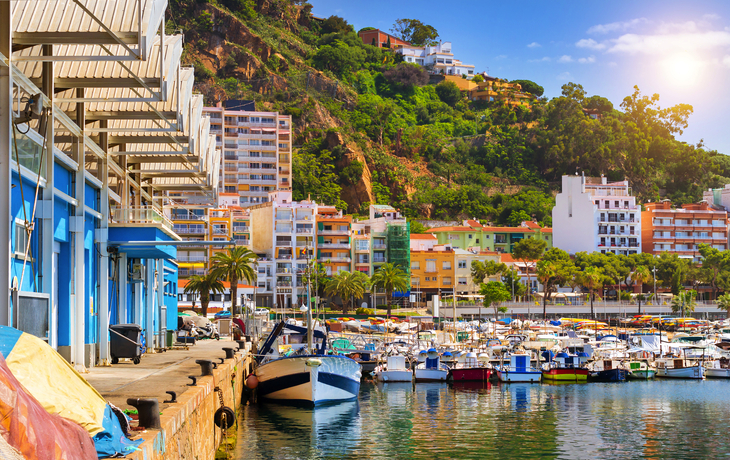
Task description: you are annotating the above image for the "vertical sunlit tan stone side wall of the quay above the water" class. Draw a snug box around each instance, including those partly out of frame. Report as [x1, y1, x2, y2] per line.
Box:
[126, 353, 252, 460]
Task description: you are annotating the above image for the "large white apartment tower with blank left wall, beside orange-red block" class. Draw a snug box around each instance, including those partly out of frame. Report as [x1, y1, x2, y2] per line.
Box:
[553, 176, 641, 255]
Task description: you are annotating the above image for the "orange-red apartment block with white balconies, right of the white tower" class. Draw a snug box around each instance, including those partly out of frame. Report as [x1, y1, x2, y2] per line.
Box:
[641, 200, 728, 262]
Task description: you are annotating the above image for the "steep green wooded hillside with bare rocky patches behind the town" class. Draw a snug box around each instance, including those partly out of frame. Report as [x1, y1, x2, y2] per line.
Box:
[166, 0, 730, 224]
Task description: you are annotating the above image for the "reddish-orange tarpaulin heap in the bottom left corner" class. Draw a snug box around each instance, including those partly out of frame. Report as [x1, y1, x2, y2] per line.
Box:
[0, 355, 97, 460]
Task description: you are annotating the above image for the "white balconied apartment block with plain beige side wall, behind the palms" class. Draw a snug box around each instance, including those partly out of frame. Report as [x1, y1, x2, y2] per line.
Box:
[249, 190, 317, 308]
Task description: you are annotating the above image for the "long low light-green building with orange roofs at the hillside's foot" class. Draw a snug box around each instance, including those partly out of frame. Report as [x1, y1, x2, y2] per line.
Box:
[428, 220, 553, 253]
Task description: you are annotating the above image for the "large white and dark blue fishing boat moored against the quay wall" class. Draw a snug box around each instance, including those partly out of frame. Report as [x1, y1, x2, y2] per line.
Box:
[255, 315, 362, 406]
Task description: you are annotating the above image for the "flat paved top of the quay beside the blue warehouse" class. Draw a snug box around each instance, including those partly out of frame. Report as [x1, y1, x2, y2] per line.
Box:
[83, 337, 238, 410]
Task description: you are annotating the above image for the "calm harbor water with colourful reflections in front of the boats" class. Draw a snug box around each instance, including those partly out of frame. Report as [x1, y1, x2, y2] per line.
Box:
[235, 380, 730, 459]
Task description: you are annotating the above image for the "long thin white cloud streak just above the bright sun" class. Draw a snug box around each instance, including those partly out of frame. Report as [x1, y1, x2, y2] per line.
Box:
[608, 30, 730, 54]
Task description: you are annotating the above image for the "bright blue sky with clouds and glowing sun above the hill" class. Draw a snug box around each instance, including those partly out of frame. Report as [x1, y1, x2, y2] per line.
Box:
[309, 0, 730, 154]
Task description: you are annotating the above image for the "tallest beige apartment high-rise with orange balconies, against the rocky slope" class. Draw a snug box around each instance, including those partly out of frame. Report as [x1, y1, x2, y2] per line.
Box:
[204, 101, 292, 207]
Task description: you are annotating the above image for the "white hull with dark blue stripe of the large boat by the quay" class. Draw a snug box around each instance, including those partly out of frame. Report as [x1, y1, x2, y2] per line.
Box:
[256, 355, 362, 406]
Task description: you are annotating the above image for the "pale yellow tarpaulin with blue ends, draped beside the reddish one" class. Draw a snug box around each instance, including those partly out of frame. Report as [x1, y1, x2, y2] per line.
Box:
[0, 326, 142, 458]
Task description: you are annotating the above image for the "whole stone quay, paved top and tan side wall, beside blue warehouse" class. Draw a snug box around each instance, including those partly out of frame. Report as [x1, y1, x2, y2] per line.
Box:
[84, 338, 253, 460]
